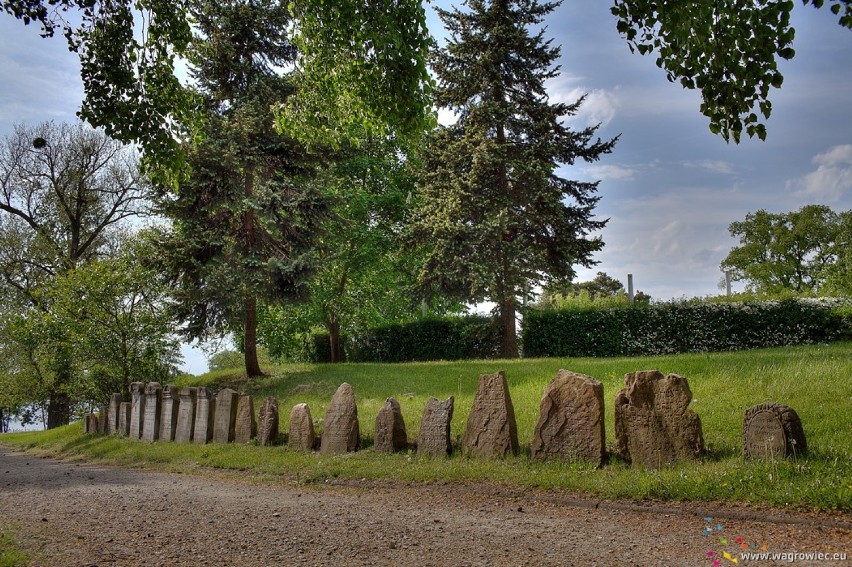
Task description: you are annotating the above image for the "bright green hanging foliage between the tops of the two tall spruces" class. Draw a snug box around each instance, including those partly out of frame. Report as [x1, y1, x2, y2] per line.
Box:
[278, 0, 431, 146]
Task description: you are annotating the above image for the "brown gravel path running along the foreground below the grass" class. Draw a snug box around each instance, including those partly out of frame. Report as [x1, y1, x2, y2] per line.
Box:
[0, 446, 852, 567]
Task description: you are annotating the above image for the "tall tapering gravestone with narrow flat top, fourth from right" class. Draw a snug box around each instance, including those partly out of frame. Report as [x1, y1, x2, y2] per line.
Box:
[462, 370, 519, 458]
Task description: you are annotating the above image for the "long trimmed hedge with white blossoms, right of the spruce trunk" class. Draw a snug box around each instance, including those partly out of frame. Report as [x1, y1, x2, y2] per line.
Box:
[522, 299, 852, 357]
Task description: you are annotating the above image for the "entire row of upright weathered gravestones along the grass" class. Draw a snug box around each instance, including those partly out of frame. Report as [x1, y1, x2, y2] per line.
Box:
[85, 370, 807, 468]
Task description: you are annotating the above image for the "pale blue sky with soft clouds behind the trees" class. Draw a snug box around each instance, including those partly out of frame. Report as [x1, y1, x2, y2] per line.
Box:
[0, 0, 852, 371]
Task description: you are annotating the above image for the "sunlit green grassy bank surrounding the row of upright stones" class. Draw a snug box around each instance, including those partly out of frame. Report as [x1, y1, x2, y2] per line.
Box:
[2, 343, 852, 512]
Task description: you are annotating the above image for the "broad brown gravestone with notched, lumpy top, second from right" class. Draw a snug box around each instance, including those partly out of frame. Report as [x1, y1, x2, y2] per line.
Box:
[615, 370, 704, 469]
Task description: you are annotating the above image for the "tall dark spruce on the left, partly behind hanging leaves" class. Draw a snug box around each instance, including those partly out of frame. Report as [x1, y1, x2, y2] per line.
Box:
[156, 0, 325, 377]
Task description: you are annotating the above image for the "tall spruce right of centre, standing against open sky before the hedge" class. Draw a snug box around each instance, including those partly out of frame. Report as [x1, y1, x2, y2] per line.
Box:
[412, 0, 616, 357]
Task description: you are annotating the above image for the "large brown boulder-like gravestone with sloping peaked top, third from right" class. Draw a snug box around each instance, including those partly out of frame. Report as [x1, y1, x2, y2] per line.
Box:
[531, 370, 606, 466]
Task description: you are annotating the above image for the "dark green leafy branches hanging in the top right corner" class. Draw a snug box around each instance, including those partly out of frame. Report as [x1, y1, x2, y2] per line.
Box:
[611, 0, 852, 143]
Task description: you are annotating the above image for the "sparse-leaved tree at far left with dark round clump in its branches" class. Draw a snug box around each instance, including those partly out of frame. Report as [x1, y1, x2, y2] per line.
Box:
[0, 123, 148, 427]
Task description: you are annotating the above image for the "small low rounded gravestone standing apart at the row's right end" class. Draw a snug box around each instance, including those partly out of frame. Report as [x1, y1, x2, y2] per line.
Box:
[743, 403, 808, 460]
